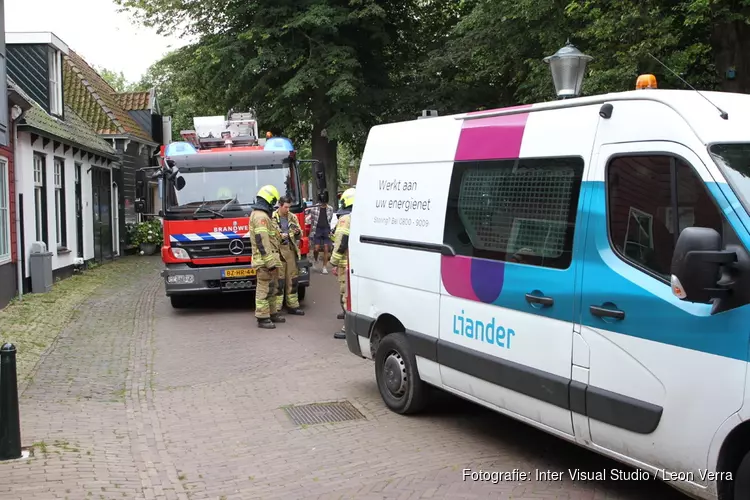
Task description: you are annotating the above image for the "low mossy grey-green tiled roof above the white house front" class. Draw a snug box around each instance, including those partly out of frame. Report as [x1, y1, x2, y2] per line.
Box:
[8, 78, 117, 158]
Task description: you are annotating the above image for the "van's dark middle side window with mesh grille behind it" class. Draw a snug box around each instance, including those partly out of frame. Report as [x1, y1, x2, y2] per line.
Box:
[444, 158, 584, 269]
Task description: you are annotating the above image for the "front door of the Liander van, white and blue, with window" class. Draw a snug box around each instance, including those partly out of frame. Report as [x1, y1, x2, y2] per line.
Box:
[580, 142, 750, 480]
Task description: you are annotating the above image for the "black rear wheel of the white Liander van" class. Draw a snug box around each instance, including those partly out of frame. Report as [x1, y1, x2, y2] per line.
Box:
[375, 333, 428, 415]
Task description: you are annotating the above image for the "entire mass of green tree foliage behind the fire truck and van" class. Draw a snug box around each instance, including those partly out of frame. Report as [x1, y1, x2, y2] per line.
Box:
[116, 0, 750, 179]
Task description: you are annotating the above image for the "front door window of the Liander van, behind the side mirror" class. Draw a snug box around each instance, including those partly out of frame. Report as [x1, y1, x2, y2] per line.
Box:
[607, 154, 723, 282]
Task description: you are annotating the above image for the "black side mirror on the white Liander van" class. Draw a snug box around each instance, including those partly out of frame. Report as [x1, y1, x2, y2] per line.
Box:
[672, 227, 750, 314]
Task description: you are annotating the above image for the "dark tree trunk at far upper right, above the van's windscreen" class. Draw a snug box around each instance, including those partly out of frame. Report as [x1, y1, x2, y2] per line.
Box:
[711, 21, 750, 93]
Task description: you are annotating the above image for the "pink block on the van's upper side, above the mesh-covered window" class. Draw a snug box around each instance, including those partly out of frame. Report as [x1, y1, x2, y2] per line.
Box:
[455, 105, 531, 161]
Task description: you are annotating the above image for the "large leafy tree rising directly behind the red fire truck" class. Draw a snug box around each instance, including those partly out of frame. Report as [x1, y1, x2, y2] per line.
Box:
[117, 0, 429, 195]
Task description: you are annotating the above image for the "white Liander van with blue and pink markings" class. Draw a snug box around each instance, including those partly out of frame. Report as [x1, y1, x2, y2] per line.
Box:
[345, 79, 750, 500]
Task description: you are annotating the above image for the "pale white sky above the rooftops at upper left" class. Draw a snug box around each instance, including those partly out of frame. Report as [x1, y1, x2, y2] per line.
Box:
[5, 0, 194, 82]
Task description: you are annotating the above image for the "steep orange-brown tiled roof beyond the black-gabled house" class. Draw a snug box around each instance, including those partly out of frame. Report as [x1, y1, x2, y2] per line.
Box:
[63, 50, 154, 143]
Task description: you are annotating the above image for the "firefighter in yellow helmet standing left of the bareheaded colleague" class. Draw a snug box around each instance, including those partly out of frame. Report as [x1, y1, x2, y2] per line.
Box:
[249, 184, 286, 329]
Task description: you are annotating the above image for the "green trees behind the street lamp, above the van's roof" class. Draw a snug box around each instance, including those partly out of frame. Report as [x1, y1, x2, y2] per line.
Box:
[425, 0, 750, 107]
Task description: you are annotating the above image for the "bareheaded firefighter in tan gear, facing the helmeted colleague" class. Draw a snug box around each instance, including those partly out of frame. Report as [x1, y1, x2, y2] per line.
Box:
[273, 196, 305, 316]
